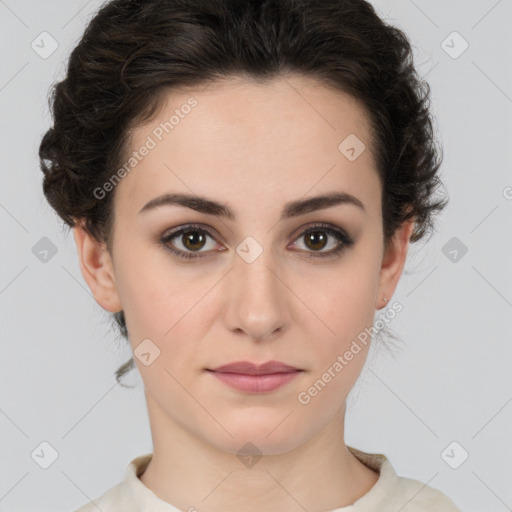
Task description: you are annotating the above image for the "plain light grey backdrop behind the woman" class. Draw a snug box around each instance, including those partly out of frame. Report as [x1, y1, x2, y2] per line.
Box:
[0, 0, 512, 512]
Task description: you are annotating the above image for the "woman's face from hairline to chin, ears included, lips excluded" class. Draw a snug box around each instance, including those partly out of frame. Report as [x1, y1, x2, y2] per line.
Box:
[76, 76, 410, 453]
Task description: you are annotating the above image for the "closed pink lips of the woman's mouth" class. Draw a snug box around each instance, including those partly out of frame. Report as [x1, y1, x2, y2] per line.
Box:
[208, 361, 303, 393]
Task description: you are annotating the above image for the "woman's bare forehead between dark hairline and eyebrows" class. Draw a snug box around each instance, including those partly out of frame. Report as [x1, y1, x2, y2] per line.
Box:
[116, 75, 380, 216]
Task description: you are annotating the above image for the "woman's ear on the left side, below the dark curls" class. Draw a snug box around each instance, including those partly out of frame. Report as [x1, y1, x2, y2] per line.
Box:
[73, 222, 123, 313]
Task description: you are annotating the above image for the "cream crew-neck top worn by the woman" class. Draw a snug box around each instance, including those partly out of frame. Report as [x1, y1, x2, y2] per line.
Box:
[75, 446, 461, 512]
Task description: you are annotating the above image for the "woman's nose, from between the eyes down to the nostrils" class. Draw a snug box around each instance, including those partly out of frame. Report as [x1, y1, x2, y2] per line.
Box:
[223, 246, 292, 341]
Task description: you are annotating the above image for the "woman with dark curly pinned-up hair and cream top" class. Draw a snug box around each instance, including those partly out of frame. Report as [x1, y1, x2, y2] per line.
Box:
[40, 0, 458, 512]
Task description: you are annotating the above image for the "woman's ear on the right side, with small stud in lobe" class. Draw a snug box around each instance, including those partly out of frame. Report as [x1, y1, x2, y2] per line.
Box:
[375, 219, 414, 309]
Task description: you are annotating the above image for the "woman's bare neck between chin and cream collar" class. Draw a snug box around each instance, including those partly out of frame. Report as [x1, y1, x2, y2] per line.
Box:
[139, 395, 379, 512]
